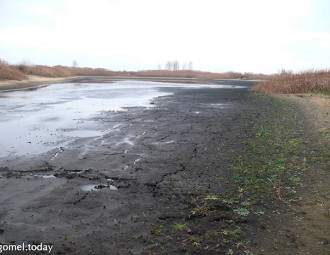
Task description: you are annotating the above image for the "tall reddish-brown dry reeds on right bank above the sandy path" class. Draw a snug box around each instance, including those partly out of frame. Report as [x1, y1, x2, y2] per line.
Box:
[252, 70, 330, 94]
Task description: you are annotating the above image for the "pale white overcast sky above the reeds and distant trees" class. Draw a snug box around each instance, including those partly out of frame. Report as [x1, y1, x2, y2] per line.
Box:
[0, 0, 330, 73]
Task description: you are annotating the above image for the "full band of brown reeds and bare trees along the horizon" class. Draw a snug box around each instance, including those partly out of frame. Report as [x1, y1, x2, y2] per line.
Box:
[0, 59, 330, 94]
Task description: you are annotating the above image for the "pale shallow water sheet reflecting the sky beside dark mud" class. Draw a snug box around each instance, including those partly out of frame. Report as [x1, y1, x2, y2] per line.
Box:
[0, 81, 245, 158]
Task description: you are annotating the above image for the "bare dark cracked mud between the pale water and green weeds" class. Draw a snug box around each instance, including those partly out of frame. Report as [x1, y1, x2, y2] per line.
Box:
[0, 80, 253, 254]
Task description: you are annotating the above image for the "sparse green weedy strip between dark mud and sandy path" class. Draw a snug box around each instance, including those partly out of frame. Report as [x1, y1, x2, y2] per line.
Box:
[146, 93, 330, 254]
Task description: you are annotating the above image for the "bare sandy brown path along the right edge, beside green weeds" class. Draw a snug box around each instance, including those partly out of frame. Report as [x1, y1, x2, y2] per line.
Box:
[258, 94, 330, 255]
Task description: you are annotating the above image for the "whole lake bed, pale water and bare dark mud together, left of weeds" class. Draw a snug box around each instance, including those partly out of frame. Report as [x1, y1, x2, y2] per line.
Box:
[0, 78, 252, 254]
